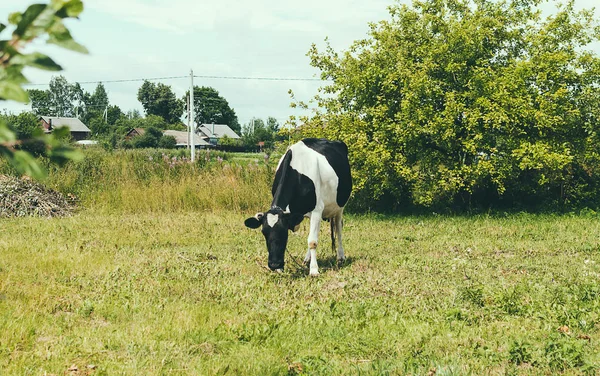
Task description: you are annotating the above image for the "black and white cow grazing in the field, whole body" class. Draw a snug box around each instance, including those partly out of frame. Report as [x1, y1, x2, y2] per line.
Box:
[244, 138, 352, 276]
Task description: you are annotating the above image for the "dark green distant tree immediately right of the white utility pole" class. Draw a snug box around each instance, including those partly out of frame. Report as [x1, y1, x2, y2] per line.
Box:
[184, 86, 241, 134]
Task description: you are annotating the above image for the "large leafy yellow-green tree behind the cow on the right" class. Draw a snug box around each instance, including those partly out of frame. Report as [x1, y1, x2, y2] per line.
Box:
[300, 0, 600, 210]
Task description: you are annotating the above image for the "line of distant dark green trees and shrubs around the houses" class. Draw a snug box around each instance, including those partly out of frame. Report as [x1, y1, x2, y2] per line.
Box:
[13, 76, 280, 150]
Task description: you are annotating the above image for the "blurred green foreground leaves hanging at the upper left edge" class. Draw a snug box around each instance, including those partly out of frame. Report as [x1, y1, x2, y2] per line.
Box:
[0, 0, 87, 178]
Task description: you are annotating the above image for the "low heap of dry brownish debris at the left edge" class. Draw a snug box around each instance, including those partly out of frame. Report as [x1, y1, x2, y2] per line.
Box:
[0, 175, 76, 218]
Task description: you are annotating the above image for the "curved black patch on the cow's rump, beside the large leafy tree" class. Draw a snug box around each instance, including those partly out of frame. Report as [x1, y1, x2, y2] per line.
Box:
[302, 138, 352, 207]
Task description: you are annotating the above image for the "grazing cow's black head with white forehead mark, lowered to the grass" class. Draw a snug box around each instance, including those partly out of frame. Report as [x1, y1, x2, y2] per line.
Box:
[244, 206, 304, 272]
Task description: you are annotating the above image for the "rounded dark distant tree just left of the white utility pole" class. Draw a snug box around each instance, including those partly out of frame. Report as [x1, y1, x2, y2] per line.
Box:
[138, 81, 184, 124]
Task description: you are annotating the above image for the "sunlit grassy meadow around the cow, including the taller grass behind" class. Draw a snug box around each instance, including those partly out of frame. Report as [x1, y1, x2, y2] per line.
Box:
[0, 151, 600, 375]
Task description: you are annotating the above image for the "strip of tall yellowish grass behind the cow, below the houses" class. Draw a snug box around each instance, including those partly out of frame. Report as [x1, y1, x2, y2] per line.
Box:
[39, 149, 276, 213]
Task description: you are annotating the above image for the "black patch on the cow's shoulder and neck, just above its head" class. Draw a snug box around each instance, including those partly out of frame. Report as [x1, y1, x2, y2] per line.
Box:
[271, 150, 317, 215]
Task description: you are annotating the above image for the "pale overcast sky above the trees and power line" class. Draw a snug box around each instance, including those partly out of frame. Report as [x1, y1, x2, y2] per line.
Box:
[0, 0, 600, 128]
